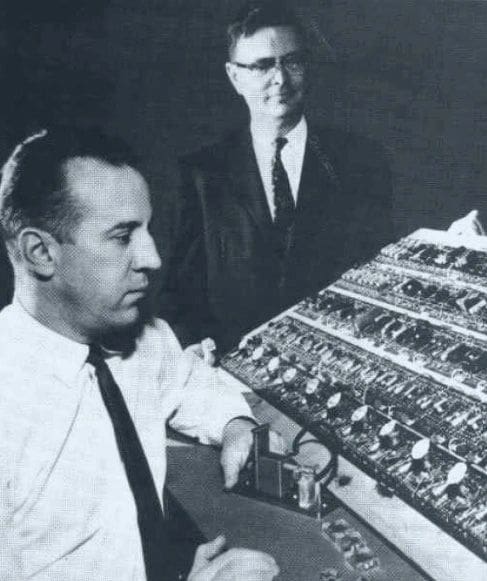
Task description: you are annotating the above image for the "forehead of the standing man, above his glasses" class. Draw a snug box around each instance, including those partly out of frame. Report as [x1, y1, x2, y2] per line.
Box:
[234, 26, 302, 62]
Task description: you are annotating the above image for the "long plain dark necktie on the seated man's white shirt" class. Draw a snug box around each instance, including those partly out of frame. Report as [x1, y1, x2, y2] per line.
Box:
[87, 345, 177, 581]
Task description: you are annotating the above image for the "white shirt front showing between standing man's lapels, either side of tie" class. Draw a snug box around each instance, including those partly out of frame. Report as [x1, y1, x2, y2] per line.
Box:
[254, 117, 308, 219]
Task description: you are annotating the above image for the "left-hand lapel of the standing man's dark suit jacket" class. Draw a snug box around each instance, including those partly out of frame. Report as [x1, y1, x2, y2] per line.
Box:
[229, 131, 272, 232]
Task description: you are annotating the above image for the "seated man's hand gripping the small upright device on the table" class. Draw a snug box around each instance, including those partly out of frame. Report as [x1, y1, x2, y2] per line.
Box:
[220, 418, 255, 489]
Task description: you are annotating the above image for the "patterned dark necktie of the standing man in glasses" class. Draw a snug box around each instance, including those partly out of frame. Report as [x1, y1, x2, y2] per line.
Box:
[272, 137, 294, 258]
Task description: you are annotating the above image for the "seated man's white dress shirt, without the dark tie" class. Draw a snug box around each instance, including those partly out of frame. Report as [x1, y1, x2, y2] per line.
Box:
[0, 301, 250, 581]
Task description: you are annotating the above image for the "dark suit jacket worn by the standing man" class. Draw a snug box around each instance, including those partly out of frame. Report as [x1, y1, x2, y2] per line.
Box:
[162, 127, 392, 350]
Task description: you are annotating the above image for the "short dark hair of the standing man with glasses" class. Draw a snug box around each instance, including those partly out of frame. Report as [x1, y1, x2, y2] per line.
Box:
[227, 0, 306, 59]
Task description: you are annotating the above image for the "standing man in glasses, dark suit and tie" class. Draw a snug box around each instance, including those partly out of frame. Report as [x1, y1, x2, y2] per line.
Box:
[163, 2, 391, 350]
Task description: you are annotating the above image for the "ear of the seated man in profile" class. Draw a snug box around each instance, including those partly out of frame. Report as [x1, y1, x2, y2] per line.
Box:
[18, 228, 59, 279]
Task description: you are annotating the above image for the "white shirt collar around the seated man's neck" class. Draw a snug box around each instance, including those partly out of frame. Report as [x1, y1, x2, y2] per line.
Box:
[10, 297, 89, 387]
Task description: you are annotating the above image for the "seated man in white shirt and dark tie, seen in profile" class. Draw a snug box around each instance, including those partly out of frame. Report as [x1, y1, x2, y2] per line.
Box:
[0, 130, 277, 581]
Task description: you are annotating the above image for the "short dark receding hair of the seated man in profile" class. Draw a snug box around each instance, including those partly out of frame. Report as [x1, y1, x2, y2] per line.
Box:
[0, 127, 138, 242]
